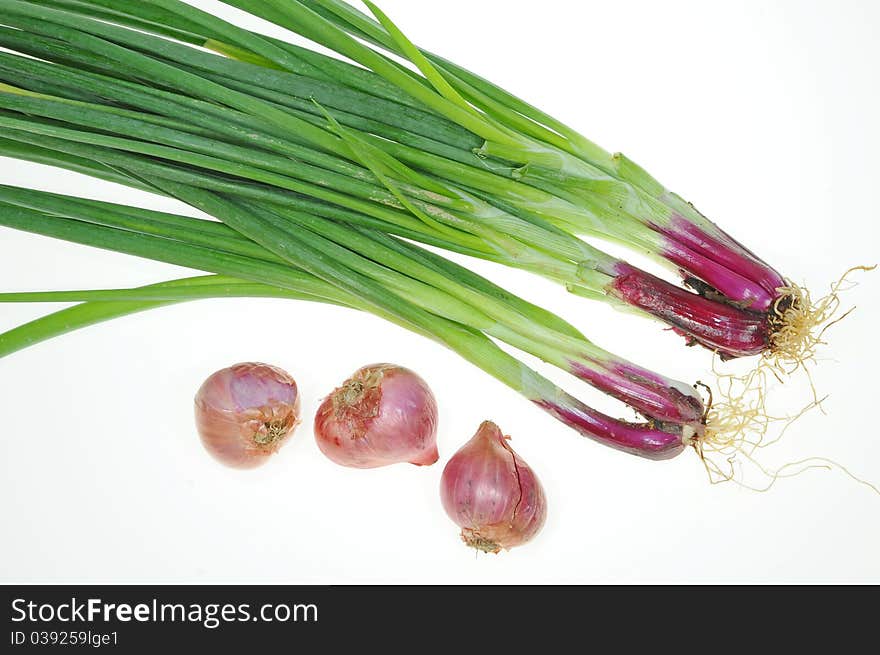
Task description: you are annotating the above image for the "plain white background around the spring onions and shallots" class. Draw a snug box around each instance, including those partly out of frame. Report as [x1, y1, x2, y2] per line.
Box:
[0, 0, 880, 583]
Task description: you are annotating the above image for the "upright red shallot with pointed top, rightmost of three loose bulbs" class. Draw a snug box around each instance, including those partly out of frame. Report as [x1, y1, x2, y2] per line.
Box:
[440, 421, 547, 553]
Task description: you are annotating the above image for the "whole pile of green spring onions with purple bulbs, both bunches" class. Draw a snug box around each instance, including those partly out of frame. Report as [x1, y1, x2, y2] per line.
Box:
[0, 0, 844, 472]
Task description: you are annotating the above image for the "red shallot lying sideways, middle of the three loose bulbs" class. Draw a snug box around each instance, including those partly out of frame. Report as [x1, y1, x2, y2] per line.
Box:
[315, 364, 440, 469]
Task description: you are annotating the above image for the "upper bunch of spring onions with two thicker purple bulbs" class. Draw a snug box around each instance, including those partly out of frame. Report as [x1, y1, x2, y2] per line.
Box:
[0, 0, 814, 364]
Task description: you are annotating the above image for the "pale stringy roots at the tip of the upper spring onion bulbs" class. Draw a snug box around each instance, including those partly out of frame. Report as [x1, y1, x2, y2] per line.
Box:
[765, 266, 877, 373]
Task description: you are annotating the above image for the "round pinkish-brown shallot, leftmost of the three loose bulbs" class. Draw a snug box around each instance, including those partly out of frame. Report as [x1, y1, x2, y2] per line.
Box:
[195, 363, 300, 469]
